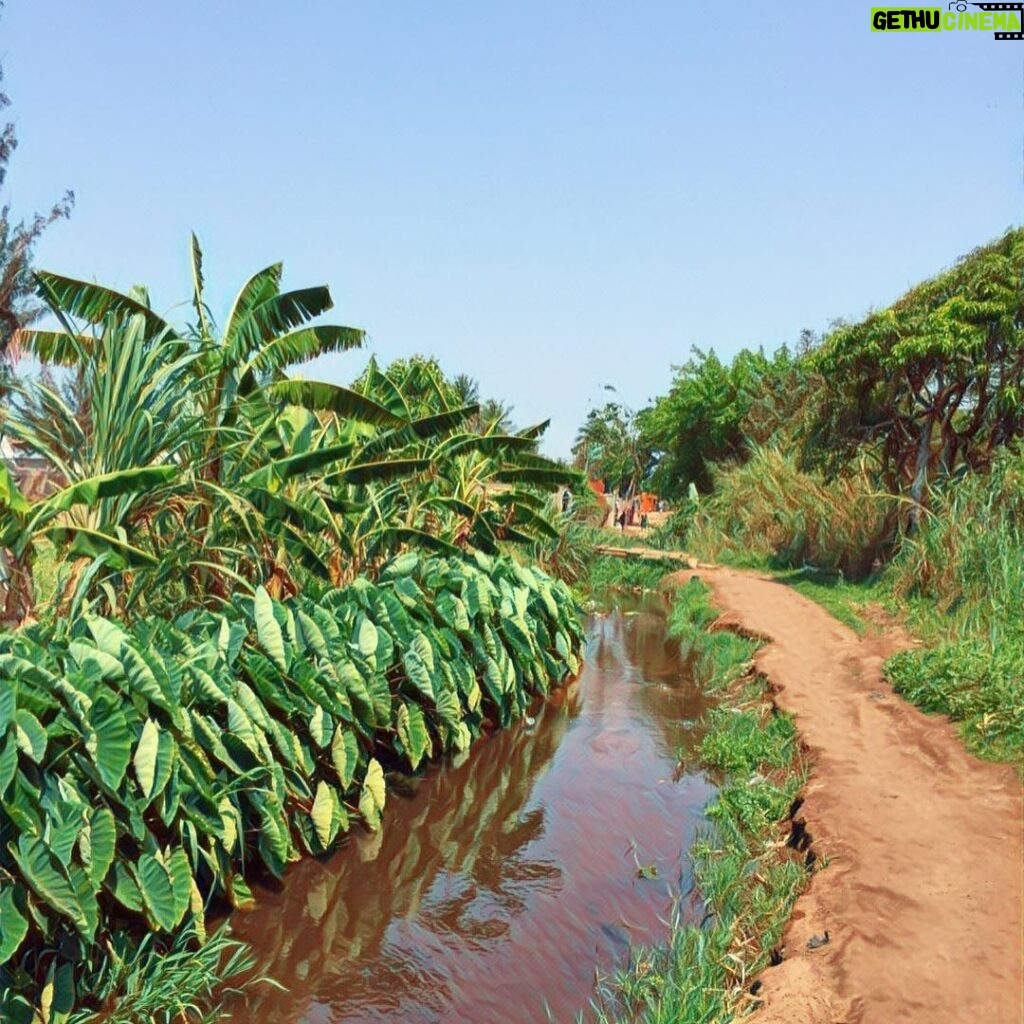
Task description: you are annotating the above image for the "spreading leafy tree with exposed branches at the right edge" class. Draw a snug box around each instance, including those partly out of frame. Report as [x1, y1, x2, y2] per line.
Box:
[813, 228, 1024, 512]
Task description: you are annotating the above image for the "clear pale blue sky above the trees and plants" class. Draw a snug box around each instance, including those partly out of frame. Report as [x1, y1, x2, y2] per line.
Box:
[0, 0, 1024, 455]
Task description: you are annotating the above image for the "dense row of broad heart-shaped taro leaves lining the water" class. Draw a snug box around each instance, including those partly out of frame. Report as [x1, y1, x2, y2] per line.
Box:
[0, 553, 582, 1019]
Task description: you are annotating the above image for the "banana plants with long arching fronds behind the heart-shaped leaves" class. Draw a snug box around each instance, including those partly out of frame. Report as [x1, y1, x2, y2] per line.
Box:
[0, 245, 575, 622]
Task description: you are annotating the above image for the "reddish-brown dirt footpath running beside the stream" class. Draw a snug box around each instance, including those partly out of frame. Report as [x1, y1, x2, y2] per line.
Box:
[696, 566, 1024, 1024]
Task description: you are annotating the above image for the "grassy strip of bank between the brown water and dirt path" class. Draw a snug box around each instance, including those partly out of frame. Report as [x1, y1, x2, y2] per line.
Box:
[593, 570, 823, 1024]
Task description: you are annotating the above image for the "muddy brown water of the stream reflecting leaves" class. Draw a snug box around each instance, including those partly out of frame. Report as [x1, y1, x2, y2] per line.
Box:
[229, 611, 713, 1024]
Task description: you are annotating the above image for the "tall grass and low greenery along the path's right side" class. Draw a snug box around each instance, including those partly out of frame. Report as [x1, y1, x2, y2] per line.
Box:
[687, 449, 1024, 768]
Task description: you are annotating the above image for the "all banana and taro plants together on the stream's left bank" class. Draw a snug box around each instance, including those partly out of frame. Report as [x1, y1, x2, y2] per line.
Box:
[0, 239, 582, 1024]
